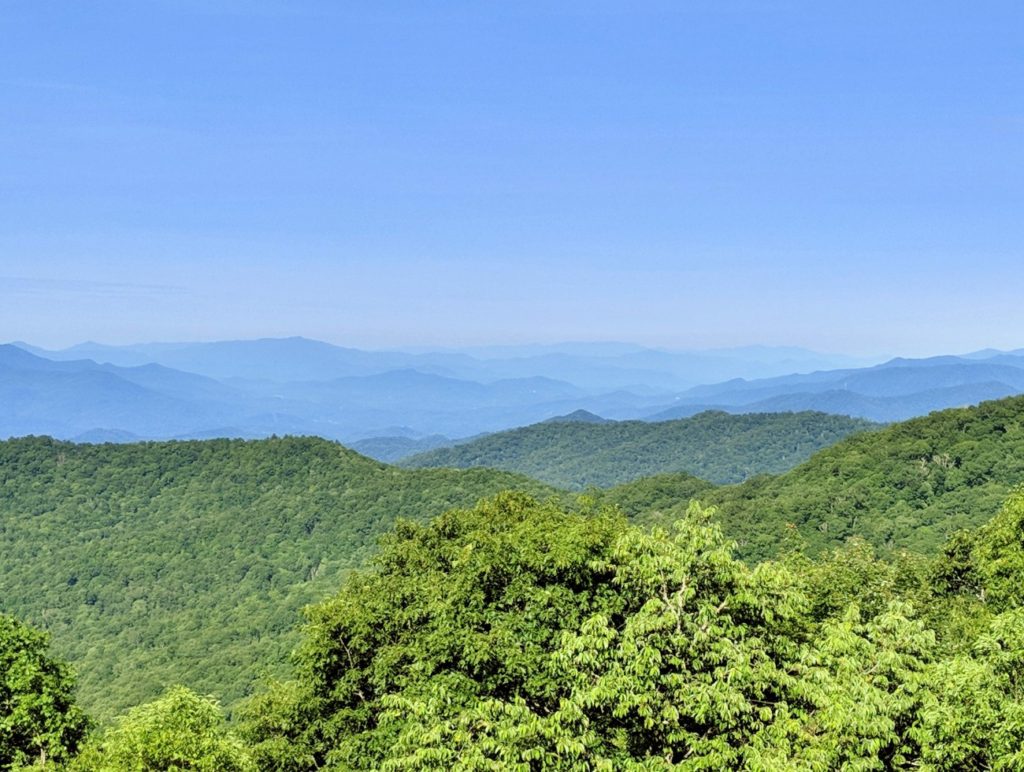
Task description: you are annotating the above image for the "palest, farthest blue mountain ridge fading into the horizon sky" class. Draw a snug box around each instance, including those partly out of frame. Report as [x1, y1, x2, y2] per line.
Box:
[18, 338, 880, 394]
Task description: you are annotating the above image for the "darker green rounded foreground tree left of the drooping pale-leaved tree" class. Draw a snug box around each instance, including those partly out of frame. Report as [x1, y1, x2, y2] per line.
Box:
[243, 494, 626, 768]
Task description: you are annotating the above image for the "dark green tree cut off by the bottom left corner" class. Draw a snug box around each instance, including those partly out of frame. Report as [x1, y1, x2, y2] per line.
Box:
[0, 614, 87, 770]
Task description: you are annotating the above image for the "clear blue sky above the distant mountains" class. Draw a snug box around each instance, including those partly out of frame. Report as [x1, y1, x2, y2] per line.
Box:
[0, 0, 1024, 355]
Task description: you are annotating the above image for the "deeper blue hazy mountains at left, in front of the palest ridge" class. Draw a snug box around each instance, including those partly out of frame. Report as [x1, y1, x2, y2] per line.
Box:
[0, 342, 665, 438]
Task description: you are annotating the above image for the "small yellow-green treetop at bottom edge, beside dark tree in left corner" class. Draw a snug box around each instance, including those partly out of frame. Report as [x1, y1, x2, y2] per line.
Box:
[73, 686, 256, 772]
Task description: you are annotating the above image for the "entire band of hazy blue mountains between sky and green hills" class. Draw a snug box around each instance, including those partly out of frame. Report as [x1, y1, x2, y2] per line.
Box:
[6, 338, 1024, 438]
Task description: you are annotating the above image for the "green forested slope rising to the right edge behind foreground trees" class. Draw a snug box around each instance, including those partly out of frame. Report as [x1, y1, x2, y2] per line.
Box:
[606, 397, 1024, 559]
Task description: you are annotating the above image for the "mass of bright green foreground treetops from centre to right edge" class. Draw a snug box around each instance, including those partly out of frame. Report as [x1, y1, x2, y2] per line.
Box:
[237, 495, 1024, 770]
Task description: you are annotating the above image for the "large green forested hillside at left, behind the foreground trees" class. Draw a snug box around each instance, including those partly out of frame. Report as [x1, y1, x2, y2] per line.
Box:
[0, 437, 551, 717]
